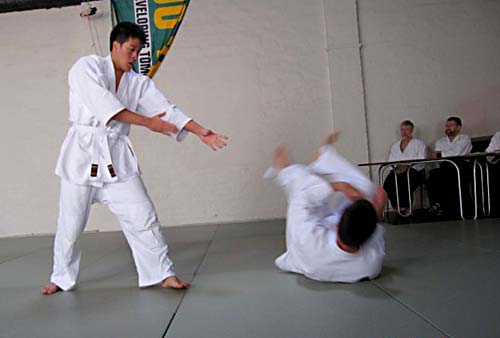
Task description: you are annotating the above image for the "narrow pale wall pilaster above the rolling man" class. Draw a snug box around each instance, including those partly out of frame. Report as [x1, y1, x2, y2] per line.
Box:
[325, 0, 370, 163]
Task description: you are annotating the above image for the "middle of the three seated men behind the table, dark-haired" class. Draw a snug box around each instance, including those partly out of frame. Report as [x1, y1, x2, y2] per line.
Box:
[427, 116, 472, 218]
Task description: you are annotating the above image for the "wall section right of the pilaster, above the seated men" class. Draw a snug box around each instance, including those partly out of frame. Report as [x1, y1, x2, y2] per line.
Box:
[359, 0, 500, 168]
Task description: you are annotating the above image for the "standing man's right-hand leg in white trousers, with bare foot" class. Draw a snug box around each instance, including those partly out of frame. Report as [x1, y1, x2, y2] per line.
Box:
[99, 176, 189, 288]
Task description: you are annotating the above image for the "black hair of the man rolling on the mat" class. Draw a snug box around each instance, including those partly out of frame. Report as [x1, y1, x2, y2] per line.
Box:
[338, 199, 377, 248]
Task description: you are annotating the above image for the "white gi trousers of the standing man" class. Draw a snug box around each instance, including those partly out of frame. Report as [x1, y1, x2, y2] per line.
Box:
[50, 176, 175, 290]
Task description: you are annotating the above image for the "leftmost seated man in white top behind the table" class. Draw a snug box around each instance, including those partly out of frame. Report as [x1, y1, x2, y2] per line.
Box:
[384, 120, 426, 213]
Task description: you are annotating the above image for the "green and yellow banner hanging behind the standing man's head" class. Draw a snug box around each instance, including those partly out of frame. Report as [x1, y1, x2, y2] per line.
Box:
[112, 0, 189, 77]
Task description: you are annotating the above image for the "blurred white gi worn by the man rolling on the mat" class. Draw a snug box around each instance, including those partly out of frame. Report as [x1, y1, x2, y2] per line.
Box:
[266, 146, 385, 283]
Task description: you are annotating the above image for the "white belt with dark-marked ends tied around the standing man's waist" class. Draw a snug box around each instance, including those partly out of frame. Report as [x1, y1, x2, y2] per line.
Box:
[71, 124, 137, 182]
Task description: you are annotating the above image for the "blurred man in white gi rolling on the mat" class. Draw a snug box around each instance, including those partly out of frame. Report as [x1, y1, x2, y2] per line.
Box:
[265, 135, 387, 283]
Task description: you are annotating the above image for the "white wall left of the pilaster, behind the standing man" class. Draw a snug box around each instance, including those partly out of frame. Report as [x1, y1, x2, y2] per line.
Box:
[0, 0, 332, 236]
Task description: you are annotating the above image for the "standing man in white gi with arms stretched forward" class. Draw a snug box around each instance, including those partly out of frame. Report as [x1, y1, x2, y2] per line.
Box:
[40, 22, 227, 295]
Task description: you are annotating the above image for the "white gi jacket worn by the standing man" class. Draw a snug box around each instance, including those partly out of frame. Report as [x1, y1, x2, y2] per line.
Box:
[55, 55, 191, 187]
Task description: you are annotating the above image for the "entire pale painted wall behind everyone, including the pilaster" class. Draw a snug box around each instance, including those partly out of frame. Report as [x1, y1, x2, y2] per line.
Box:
[0, 0, 500, 236]
